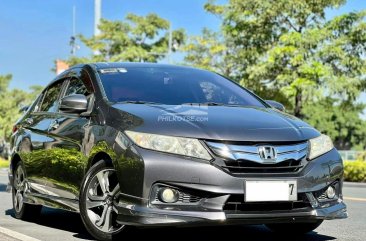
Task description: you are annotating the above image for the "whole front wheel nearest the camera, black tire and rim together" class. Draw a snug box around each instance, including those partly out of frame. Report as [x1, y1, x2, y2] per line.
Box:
[79, 161, 125, 241]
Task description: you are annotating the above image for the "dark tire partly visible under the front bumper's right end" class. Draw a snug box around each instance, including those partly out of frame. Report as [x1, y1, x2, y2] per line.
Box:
[266, 220, 323, 235]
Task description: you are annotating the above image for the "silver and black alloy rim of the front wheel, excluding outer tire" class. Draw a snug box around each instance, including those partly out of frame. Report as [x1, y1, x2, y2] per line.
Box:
[85, 169, 124, 234]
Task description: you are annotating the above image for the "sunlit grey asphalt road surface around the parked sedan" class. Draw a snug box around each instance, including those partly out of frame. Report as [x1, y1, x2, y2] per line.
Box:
[0, 170, 366, 241]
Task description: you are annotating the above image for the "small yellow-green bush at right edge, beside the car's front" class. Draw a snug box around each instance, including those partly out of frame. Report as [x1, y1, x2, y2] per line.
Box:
[344, 160, 366, 182]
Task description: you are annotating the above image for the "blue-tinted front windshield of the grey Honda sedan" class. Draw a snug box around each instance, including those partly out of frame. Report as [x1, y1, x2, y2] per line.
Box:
[99, 67, 264, 107]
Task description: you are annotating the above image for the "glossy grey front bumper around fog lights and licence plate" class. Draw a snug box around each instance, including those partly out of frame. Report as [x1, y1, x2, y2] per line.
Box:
[113, 147, 347, 226]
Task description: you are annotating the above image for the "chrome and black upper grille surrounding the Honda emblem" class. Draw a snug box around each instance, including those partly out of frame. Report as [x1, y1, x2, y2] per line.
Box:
[206, 141, 308, 175]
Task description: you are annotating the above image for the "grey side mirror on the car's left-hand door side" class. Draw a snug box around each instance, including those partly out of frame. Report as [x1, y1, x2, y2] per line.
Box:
[60, 94, 88, 114]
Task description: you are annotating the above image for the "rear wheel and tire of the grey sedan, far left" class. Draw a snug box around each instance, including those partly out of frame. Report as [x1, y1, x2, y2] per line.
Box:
[12, 162, 42, 221]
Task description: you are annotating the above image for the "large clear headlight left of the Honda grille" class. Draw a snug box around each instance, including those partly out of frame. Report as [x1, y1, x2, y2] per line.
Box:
[125, 131, 212, 160]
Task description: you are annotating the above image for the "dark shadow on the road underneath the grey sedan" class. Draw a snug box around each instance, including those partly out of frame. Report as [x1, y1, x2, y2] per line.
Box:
[6, 208, 336, 241]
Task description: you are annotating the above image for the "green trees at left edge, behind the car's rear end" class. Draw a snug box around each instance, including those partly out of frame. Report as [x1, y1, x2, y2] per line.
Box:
[0, 75, 41, 140]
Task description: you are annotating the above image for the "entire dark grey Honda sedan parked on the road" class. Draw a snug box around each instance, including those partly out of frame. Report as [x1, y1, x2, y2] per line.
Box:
[9, 63, 347, 240]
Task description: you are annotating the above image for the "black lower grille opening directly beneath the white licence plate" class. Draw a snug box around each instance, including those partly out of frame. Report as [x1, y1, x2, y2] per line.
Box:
[224, 193, 311, 212]
